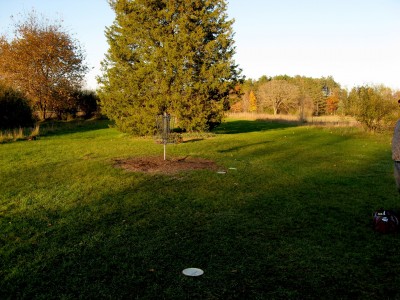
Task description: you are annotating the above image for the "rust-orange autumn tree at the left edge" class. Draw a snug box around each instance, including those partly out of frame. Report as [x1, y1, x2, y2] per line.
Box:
[0, 11, 87, 119]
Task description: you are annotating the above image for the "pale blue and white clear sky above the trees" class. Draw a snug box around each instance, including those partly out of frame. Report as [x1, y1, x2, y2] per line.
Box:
[0, 0, 400, 90]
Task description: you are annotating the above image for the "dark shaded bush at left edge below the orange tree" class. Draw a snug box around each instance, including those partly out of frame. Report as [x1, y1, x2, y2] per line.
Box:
[0, 86, 35, 129]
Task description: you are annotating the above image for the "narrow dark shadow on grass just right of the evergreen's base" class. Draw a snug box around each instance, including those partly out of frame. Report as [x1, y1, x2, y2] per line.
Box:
[213, 120, 299, 134]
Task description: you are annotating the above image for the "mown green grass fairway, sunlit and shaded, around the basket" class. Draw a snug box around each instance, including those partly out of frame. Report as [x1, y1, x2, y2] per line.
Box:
[0, 119, 400, 299]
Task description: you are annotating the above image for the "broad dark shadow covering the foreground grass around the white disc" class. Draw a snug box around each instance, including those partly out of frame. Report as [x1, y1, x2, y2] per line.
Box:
[0, 150, 400, 299]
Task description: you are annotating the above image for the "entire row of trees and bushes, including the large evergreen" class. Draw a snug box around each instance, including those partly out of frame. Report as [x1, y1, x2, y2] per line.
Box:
[0, 8, 400, 135]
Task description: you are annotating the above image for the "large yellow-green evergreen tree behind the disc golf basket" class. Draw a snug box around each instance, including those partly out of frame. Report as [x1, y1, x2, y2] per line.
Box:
[98, 0, 240, 135]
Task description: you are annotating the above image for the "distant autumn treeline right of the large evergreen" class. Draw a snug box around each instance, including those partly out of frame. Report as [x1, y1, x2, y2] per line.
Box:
[230, 75, 400, 130]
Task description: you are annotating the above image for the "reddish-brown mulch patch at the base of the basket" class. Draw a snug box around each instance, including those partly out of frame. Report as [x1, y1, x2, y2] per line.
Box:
[114, 156, 223, 174]
